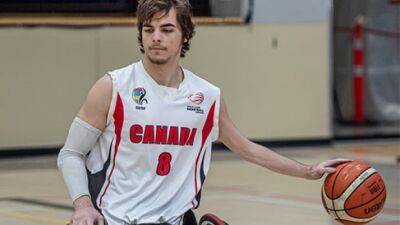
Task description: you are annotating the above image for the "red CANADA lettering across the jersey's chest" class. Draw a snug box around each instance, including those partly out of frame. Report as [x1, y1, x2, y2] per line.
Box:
[130, 124, 197, 146]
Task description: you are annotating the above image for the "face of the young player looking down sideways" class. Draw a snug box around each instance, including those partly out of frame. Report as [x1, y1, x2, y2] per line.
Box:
[142, 8, 182, 64]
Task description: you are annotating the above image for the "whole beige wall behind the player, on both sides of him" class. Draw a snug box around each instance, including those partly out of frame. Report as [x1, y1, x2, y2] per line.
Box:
[0, 23, 331, 149]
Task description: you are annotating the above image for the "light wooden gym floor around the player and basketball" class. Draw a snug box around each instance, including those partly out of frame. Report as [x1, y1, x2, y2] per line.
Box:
[0, 143, 400, 225]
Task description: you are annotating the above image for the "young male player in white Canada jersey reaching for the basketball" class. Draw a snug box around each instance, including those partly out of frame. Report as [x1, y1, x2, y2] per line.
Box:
[58, 0, 346, 225]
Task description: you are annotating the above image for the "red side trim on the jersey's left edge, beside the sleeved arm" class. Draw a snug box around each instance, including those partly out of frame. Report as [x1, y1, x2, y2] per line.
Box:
[99, 94, 124, 208]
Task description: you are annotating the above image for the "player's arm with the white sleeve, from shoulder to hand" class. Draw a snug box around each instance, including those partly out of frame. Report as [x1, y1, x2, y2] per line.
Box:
[58, 76, 113, 225]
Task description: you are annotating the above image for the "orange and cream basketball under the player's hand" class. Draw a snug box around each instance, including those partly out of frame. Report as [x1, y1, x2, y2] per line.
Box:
[321, 161, 386, 225]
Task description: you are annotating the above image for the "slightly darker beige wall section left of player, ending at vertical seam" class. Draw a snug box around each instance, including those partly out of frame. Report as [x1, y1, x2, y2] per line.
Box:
[0, 28, 96, 148]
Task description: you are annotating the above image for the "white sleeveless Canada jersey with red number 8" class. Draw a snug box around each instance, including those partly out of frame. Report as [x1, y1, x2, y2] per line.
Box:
[86, 61, 220, 225]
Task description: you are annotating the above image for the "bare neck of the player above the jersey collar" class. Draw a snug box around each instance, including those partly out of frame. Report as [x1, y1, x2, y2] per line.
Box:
[142, 57, 183, 88]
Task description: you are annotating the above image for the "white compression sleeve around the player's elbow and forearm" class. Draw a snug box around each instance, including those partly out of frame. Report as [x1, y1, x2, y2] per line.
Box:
[57, 117, 102, 201]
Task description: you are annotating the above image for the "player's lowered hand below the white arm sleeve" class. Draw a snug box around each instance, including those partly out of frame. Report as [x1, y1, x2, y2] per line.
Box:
[69, 195, 105, 225]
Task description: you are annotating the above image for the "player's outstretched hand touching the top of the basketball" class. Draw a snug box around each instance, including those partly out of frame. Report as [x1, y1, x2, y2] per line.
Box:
[307, 159, 353, 180]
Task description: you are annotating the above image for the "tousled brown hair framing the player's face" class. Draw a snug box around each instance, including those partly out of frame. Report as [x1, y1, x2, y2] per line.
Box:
[136, 0, 195, 57]
